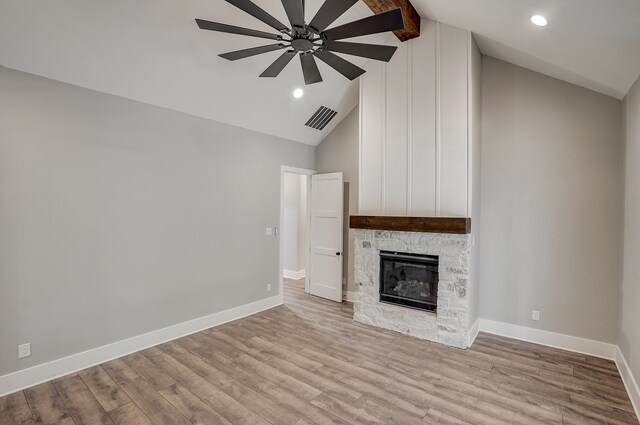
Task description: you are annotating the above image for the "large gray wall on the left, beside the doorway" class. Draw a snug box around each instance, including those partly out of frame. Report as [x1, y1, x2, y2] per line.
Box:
[0, 68, 315, 375]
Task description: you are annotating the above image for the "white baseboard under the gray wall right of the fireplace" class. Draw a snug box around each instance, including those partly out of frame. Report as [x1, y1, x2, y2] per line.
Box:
[479, 319, 618, 360]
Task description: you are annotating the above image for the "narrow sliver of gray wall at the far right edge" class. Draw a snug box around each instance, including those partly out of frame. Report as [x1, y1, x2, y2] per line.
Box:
[618, 73, 640, 380]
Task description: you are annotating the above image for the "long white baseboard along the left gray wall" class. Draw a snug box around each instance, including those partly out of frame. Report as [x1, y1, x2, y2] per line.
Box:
[0, 295, 282, 397]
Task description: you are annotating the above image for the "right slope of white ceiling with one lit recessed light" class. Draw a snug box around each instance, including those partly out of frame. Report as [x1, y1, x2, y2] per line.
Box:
[412, 0, 640, 99]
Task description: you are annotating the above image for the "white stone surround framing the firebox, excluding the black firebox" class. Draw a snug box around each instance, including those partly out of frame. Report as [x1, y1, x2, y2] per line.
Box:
[351, 218, 472, 348]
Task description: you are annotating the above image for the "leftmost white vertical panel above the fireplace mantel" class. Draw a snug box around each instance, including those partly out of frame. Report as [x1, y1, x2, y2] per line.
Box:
[358, 62, 386, 215]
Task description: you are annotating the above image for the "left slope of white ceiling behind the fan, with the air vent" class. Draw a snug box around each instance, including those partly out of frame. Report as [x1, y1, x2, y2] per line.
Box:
[0, 0, 382, 145]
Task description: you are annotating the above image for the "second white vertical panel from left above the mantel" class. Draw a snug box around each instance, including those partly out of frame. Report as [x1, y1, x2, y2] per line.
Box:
[383, 43, 409, 216]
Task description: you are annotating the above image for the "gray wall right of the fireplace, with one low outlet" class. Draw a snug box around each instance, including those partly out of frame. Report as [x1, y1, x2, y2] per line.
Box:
[480, 57, 624, 343]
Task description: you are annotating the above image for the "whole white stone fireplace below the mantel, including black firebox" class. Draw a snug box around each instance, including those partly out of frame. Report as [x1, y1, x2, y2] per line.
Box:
[353, 229, 477, 348]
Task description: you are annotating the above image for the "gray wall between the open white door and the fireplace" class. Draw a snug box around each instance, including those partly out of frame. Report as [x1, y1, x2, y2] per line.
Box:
[315, 107, 360, 291]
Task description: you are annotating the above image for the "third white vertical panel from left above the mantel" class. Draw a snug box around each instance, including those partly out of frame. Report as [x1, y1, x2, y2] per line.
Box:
[407, 19, 436, 216]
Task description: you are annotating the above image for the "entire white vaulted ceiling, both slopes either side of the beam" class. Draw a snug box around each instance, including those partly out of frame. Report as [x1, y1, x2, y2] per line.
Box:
[0, 0, 640, 145]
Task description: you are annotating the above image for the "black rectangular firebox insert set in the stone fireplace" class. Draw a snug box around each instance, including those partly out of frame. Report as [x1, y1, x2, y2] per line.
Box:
[380, 251, 438, 312]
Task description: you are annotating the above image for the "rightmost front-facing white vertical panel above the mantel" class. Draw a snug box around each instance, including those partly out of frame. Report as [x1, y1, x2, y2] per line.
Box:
[437, 24, 469, 217]
